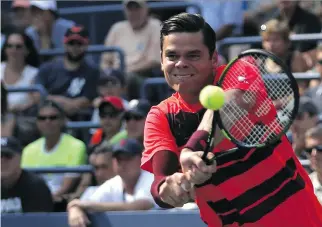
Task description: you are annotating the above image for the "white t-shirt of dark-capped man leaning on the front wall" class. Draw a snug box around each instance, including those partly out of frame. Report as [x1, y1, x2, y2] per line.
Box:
[88, 170, 156, 206]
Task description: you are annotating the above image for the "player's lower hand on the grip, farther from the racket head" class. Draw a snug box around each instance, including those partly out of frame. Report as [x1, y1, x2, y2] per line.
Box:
[159, 173, 193, 207]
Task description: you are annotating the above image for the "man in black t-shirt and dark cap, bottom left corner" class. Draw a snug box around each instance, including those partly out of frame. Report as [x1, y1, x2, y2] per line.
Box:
[1, 137, 53, 214]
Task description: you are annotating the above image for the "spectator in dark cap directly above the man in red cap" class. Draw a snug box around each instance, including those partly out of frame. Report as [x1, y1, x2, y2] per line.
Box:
[92, 69, 129, 123]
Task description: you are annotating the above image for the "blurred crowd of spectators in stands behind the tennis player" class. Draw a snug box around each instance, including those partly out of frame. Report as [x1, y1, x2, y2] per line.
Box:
[0, 0, 322, 223]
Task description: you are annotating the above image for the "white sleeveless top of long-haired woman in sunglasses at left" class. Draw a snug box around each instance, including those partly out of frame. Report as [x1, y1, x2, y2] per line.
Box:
[0, 62, 38, 108]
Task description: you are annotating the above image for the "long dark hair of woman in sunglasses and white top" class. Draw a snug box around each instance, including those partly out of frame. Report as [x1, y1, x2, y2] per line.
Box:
[1, 28, 40, 68]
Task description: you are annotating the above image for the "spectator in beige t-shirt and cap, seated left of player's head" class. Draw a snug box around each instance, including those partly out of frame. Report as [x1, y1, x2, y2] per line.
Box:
[101, 0, 161, 100]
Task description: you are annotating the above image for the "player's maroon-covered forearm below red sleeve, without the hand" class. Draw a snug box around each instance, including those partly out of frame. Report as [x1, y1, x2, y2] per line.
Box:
[151, 150, 179, 208]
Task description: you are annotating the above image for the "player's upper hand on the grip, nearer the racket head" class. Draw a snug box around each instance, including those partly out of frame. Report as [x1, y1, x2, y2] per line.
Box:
[180, 148, 217, 184]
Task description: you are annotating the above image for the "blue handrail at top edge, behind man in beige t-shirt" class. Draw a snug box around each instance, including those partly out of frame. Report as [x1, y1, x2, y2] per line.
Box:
[59, 1, 201, 15]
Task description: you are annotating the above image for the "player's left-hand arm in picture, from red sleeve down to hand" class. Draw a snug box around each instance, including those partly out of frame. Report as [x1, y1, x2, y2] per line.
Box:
[142, 107, 191, 208]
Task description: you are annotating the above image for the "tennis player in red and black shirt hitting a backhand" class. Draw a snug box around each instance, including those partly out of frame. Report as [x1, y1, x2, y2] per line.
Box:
[142, 13, 322, 227]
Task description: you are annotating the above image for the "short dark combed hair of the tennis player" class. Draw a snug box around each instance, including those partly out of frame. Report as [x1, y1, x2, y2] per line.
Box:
[160, 13, 216, 57]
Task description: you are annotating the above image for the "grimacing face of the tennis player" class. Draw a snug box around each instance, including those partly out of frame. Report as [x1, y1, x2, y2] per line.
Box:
[161, 32, 215, 95]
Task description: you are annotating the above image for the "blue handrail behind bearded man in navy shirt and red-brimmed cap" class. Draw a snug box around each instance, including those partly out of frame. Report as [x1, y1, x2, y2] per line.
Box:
[40, 45, 125, 71]
